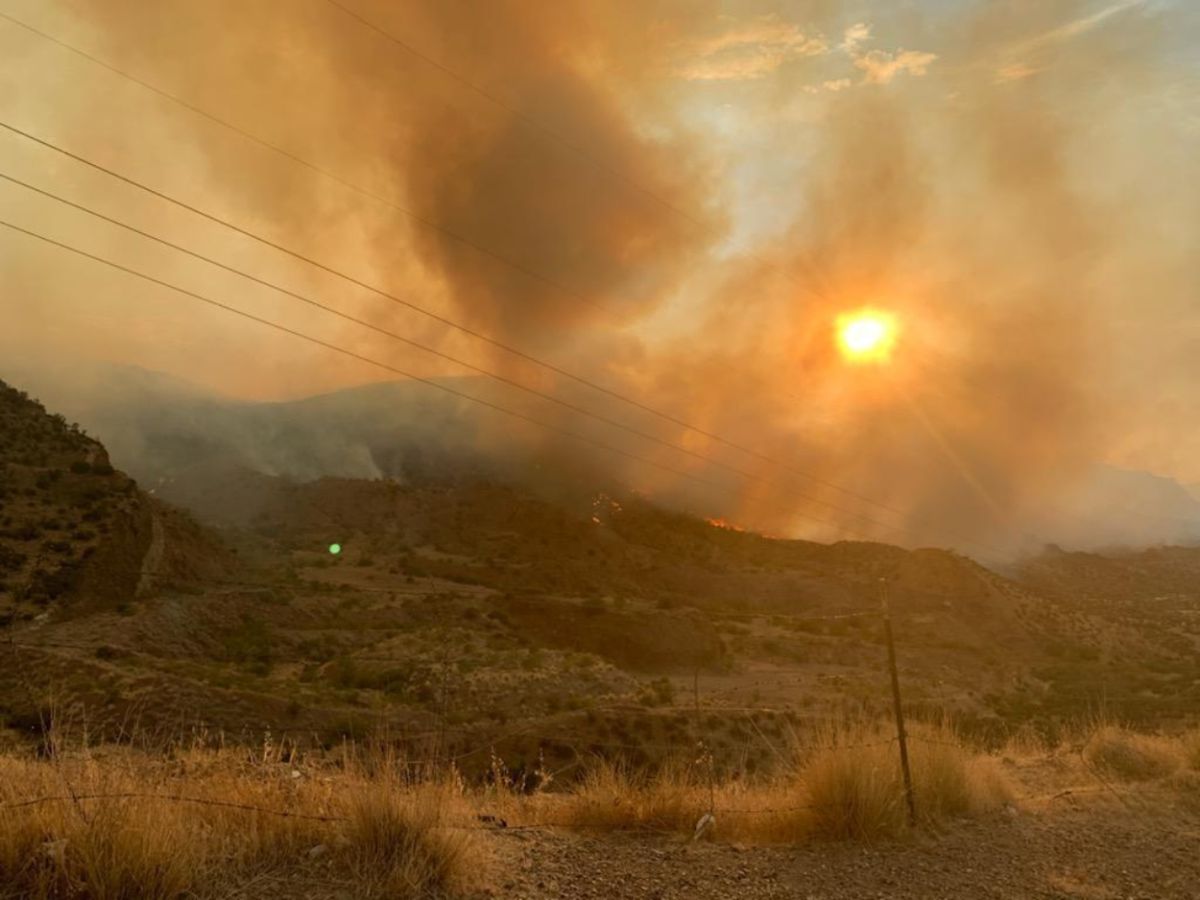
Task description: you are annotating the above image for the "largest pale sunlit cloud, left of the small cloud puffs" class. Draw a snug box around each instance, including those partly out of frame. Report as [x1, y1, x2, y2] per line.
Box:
[678, 16, 829, 82]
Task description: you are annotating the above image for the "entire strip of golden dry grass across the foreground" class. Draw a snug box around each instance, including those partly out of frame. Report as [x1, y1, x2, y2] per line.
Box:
[0, 724, 1200, 900]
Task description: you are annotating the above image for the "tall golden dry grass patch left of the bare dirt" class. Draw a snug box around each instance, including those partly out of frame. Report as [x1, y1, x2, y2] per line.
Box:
[0, 752, 486, 900]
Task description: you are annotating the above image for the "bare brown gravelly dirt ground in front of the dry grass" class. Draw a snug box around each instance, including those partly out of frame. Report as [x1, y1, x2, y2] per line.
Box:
[482, 798, 1200, 900]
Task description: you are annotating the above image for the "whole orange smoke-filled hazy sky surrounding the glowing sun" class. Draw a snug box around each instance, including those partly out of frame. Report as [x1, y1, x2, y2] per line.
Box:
[0, 0, 1200, 549]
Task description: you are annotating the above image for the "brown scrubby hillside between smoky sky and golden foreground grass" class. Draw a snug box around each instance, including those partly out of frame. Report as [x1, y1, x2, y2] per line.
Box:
[5, 376, 1196, 772]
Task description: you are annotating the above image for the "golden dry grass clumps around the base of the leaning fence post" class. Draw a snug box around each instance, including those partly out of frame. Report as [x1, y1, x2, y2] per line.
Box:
[508, 726, 1010, 844]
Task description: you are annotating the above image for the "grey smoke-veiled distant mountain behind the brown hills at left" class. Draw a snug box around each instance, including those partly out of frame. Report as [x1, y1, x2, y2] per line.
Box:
[4, 366, 491, 497]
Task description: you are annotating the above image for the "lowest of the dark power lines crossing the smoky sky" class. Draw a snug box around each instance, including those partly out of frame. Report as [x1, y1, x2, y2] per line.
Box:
[0, 218, 872, 540]
